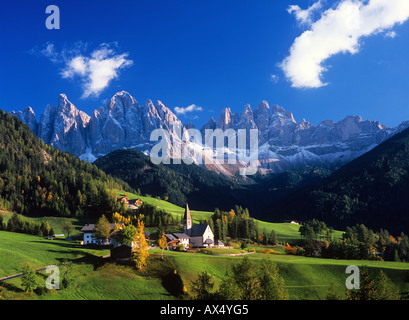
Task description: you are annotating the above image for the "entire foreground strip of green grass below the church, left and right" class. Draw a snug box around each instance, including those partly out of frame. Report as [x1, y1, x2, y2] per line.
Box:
[0, 231, 409, 300]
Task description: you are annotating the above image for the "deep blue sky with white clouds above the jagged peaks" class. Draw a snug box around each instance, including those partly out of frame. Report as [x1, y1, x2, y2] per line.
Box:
[0, 0, 409, 127]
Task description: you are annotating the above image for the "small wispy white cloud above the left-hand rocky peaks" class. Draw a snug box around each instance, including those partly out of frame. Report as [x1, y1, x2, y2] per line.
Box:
[61, 44, 133, 98]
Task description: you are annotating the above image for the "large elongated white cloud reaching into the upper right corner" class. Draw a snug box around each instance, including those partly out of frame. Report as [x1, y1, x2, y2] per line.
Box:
[280, 0, 409, 88]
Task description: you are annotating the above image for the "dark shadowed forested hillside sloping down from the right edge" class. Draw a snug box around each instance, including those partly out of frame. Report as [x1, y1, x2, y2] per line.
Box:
[265, 129, 409, 234]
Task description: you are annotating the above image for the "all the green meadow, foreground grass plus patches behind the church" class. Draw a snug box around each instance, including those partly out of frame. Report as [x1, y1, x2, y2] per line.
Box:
[0, 191, 409, 300]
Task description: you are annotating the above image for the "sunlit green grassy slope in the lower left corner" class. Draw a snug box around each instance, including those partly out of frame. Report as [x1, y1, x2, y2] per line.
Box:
[0, 231, 174, 300]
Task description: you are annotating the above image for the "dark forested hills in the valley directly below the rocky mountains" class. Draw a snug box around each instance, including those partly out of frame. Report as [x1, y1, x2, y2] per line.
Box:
[95, 149, 331, 217]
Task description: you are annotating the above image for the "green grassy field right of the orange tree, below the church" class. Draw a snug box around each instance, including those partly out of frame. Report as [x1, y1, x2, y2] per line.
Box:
[155, 248, 409, 300]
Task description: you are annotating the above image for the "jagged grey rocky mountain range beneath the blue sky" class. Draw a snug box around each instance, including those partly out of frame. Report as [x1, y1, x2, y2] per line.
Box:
[11, 91, 409, 176]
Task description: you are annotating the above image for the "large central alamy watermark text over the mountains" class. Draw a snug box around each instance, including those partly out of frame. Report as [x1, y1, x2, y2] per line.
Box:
[150, 125, 259, 175]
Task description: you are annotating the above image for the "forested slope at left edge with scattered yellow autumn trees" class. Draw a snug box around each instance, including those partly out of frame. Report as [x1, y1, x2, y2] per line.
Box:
[0, 111, 132, 217]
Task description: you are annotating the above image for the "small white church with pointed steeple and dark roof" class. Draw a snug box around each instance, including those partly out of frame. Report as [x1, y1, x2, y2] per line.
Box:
[165, 204, 215, 248]
